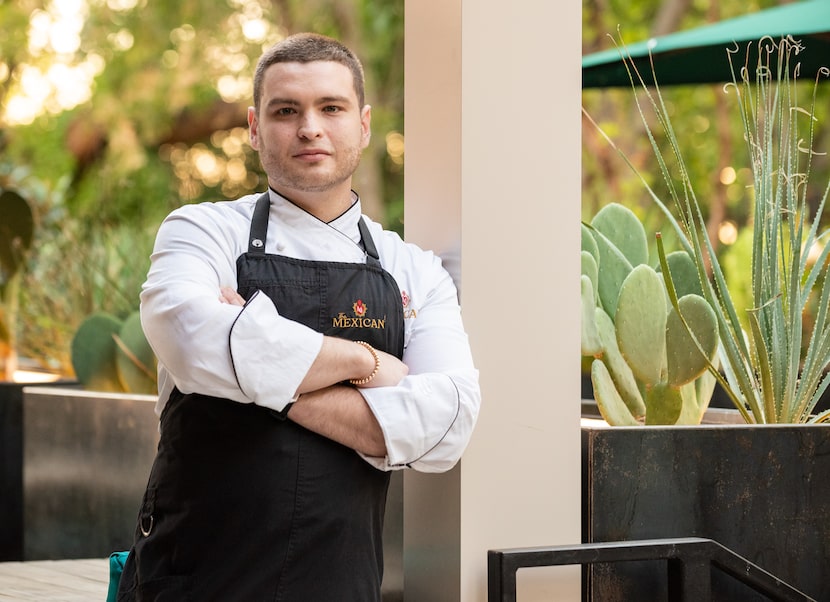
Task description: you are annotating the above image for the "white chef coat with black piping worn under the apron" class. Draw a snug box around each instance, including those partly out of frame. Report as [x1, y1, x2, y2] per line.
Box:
[141, 190, 481, 472]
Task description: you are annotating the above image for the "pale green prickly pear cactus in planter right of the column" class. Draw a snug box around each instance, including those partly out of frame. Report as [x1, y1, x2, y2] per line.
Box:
[582, 203, 718, 425]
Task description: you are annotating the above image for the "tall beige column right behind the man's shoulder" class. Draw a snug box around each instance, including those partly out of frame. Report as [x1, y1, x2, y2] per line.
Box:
[404, 0, 582, 602]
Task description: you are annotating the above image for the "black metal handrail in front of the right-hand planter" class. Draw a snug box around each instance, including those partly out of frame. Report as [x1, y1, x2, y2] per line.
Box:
[487, 537, 815, 602]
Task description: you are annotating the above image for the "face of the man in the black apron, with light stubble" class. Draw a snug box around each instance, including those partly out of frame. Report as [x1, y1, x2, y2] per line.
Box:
[248, 61, 370, 200]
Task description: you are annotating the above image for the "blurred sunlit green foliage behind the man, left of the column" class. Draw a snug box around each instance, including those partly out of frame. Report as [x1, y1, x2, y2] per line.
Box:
[0, 0, 404, 374]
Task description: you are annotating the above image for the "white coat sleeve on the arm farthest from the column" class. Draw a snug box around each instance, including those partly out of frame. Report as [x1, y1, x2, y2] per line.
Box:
[141, 205, 323, 411]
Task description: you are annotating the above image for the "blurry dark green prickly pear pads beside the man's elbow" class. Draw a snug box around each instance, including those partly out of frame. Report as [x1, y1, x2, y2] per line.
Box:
[72, 312, 156, 394]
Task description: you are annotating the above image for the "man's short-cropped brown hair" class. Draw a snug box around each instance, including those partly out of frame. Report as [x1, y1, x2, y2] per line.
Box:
[254, 33, 366, 113]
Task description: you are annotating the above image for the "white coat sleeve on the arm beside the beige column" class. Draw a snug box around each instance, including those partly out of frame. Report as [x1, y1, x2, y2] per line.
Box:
[360, 269, 481, 472]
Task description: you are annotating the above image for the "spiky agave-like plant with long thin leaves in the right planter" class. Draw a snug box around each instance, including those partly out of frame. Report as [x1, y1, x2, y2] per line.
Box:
[589, 37, 830, 423]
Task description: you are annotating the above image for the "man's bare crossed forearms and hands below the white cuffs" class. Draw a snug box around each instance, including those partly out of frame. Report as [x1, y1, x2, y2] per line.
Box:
[219, 287, 409, 457]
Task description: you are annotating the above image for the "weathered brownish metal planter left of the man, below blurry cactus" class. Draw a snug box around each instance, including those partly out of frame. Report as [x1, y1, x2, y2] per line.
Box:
[22, 387, 158, 560]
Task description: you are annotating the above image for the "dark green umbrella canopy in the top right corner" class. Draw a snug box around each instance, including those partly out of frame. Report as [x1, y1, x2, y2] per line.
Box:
[582, 0, 830, 88]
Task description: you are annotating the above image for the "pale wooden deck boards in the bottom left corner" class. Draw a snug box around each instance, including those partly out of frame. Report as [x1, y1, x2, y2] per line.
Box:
[0, 558, 109, 602]
